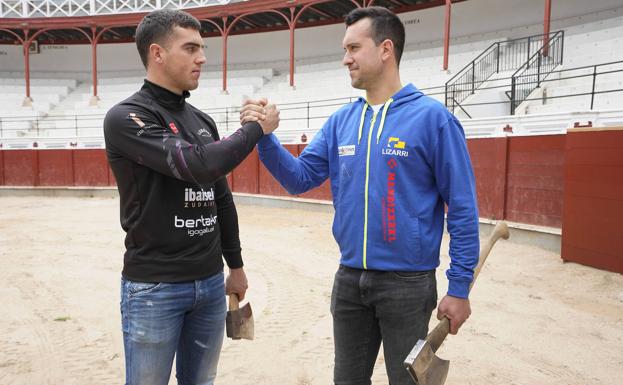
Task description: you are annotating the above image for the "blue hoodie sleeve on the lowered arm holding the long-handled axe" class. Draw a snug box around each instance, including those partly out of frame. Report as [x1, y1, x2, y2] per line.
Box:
[433, 118, 480, 298]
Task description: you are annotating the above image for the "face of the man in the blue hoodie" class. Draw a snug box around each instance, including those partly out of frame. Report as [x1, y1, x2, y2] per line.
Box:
[342, 18, 383, 90]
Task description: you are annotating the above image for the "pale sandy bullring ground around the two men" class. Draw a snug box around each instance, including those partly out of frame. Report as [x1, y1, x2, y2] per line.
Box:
[0, 197, 623, 385]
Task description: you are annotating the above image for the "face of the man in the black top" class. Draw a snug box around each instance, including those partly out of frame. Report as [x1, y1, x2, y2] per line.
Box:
[157, 27, 206, 91]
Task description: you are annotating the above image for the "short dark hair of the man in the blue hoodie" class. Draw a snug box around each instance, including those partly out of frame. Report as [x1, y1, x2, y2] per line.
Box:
[344, 7, 405, 64]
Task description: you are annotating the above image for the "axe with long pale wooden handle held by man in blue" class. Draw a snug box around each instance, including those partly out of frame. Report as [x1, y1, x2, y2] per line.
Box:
[403, 222, 510, 385]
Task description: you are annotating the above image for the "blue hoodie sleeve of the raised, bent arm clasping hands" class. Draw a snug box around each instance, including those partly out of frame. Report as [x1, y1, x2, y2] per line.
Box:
[257, 122, 329, 194]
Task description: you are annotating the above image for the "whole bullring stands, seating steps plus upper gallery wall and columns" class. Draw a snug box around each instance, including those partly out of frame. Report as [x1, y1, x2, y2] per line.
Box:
[0, 0, 623, 148]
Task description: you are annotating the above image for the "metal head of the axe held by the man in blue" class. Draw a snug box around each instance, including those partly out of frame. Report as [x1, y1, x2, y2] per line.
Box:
[403, 340, 450, 385]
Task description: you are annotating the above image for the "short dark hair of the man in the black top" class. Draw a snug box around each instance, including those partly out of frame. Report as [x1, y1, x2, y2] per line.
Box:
[135, 9, 201, 68]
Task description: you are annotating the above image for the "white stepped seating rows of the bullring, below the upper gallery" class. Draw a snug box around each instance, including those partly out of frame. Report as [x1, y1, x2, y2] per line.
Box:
[0, 3, 623, 143]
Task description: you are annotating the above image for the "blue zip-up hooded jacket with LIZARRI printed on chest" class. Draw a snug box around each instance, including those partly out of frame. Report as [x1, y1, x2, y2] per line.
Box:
[258, 84, 479, 298]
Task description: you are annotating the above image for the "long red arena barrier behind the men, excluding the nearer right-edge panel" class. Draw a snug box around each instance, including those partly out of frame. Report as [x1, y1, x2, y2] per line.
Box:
[0, 135, 565, 231]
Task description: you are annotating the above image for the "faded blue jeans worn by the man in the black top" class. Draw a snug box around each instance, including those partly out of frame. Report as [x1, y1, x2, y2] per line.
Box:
[121, 272, 227, 385]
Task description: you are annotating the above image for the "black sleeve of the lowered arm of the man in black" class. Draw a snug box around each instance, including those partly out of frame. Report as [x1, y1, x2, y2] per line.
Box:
[214, 178, 243, 269]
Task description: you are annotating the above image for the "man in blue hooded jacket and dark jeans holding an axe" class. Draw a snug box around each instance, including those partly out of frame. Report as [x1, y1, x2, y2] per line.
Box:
[241, 7, 479, 385]
